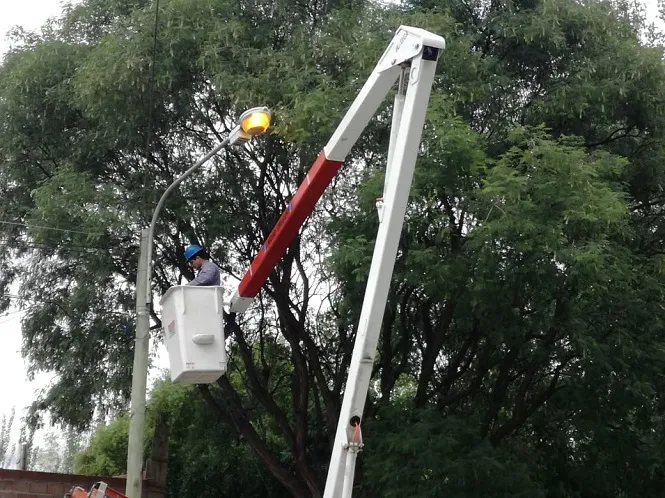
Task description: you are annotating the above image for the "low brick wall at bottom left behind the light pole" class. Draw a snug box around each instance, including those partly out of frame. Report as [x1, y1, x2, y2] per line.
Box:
[0, 469, 165, 498]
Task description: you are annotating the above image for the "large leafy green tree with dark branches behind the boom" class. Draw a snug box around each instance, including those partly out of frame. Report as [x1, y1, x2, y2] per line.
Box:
[0, 0, 665, 497]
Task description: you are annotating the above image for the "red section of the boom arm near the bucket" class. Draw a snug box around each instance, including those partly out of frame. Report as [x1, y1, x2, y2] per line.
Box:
[238, 151, 343, 298]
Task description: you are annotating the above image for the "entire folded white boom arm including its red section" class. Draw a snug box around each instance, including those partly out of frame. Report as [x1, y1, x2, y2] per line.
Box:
[230, 26, 445, 498]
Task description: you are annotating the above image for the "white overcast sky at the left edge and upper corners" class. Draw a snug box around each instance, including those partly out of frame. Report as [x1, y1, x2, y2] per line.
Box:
[0, 0, 660, 468]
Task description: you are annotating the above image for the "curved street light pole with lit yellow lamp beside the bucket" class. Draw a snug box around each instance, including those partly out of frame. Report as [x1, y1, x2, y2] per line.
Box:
[125, 107, 271, 498]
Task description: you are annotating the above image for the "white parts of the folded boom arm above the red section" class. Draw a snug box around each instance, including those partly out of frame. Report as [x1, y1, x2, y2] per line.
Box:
[324, 26, 445, 498]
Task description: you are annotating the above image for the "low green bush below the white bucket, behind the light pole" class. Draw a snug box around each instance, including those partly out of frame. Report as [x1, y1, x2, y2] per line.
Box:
[74, 381, 285, 498]
